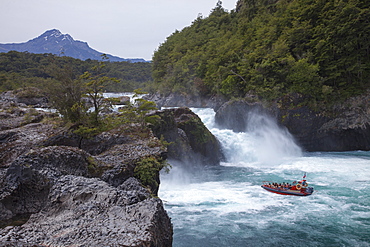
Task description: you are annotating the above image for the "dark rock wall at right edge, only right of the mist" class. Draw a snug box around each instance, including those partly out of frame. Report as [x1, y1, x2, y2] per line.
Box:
[279, 91, 370, 151]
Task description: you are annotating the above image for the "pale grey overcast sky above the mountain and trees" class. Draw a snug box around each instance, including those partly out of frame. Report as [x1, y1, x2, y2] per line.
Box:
[0, 0, 237, 60]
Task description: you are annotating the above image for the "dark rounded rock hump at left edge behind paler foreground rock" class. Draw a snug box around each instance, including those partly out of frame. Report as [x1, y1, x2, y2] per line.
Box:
[0, 147, 88, 229]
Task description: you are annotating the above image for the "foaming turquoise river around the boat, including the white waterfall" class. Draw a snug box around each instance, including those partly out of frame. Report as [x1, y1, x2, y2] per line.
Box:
[159, 109, 370, 247]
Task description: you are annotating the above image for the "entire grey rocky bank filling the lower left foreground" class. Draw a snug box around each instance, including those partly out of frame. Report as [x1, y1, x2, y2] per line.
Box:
[0, 92, 172, 246]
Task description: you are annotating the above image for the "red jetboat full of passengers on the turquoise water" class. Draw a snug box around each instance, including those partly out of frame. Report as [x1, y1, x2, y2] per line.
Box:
[261, 174, 314, 196]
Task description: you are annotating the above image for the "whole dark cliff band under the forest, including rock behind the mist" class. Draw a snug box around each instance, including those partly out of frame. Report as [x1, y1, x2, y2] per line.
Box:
[216, 92, 370, 151]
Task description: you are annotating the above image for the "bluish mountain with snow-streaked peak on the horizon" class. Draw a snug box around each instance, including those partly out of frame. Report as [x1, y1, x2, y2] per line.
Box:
[0, 29, 146, 63]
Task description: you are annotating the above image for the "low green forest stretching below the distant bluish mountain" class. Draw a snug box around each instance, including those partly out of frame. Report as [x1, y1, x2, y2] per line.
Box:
[0, 51, 152, 92]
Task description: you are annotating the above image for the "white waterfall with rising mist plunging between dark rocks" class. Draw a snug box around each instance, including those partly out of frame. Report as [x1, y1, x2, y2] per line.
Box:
[192, 108, 302, 166]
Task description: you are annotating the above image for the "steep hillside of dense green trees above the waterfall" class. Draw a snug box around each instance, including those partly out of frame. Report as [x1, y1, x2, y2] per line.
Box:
[153, 0, 370, 102]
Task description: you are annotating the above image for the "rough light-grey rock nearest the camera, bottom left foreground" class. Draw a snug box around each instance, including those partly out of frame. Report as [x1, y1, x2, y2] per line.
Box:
[0, 175, 172, 247]
